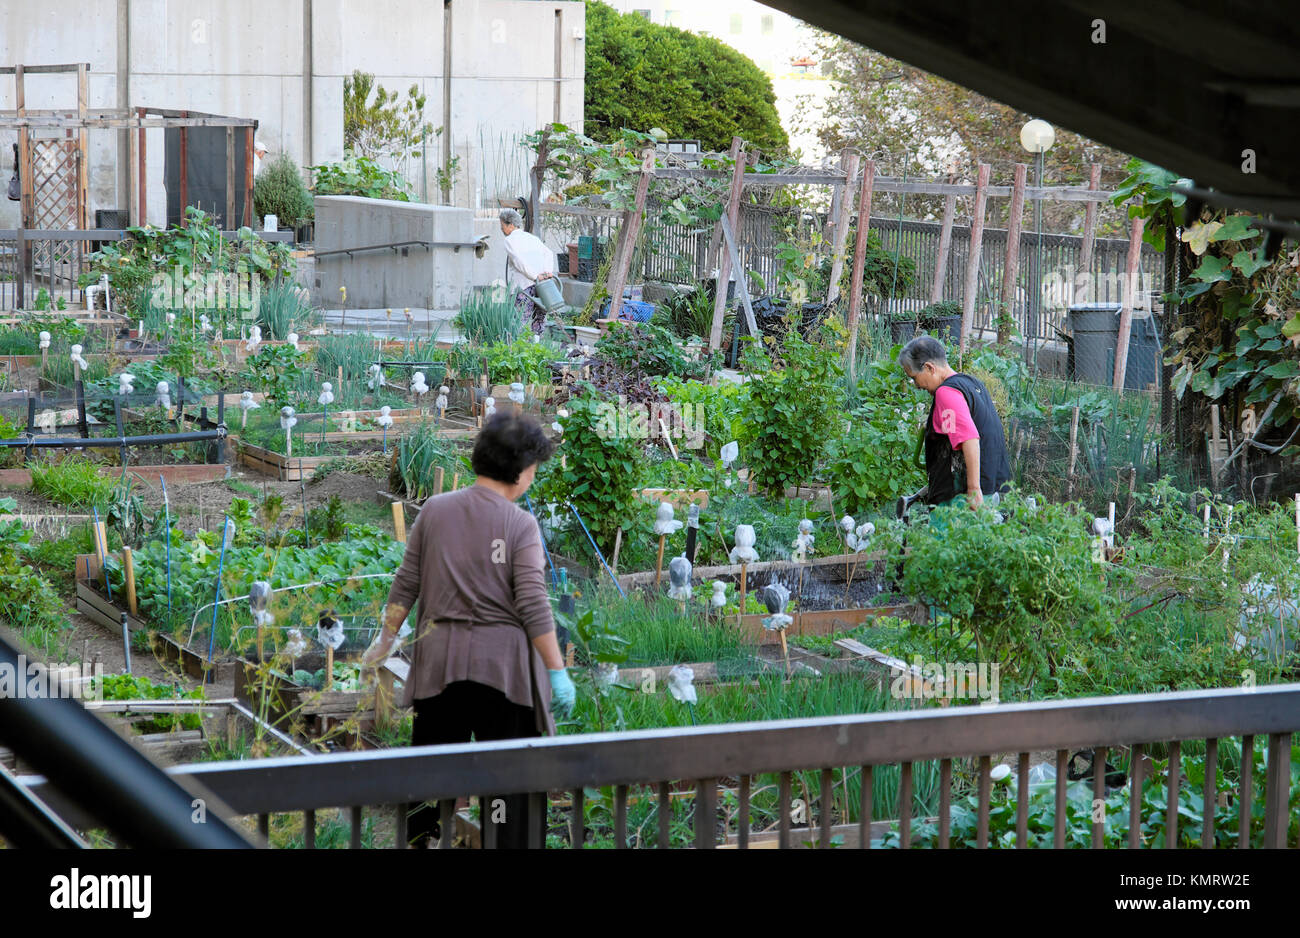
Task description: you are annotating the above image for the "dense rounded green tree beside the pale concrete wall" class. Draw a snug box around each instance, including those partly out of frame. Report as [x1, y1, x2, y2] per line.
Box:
[584, 0, 789, 152]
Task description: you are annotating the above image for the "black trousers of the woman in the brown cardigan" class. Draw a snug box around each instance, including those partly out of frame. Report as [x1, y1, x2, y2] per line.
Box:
[408, 681, 546, 850]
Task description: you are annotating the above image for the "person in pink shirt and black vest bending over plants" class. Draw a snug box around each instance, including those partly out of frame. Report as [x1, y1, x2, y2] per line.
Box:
[898, 335, 1011, 509]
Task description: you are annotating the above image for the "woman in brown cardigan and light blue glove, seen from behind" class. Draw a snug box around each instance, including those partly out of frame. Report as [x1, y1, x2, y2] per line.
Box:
[363, 412, 573, 847]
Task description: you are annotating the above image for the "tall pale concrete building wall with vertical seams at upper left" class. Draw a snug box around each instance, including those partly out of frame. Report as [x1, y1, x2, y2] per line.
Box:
[0, 0, 585, 227]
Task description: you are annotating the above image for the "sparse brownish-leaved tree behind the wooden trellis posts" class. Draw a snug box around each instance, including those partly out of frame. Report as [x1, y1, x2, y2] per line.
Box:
[811, 32, 1128, 235]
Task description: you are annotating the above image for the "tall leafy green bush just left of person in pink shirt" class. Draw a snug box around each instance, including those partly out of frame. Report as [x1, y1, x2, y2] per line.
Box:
[741, 330, 842, 498]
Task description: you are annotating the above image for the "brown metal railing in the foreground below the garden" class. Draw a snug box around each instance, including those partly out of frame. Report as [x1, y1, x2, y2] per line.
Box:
[22, 683, 1300, 847]
